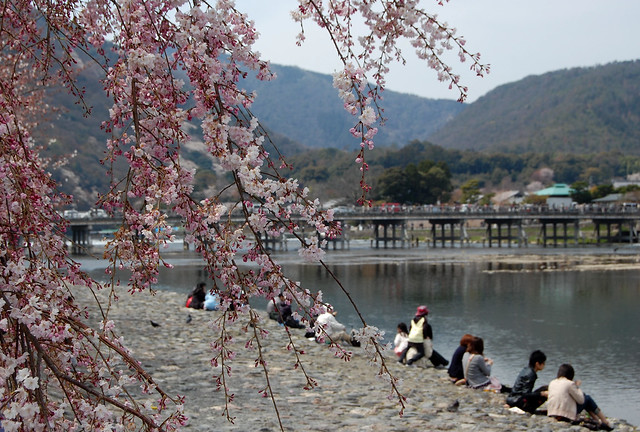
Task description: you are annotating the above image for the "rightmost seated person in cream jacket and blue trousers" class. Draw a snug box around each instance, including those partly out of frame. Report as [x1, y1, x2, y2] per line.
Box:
[547, 363, 613, 431]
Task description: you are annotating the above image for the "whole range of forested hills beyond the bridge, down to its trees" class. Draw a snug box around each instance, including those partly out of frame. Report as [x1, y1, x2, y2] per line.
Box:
[36, 55, 640, 208]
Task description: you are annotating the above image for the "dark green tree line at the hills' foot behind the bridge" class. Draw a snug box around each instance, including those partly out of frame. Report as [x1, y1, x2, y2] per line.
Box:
[291, 141, 640, 204]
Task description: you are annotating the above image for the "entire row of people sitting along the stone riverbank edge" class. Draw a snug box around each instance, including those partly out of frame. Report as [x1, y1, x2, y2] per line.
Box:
[186, 292, 613, 431]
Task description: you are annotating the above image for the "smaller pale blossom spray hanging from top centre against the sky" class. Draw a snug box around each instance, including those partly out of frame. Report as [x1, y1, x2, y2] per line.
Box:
[291, 0, 490, 204]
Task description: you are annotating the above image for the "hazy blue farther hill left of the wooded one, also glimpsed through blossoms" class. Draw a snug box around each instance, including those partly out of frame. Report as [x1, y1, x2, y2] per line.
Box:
[35, 55, 465, 209]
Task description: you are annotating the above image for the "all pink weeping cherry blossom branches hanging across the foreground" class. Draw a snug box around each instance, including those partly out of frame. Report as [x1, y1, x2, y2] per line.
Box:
[0, 0, 480, 431]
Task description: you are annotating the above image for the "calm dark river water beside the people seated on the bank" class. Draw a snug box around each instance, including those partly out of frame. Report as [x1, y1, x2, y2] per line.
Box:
[82, 246, 640, 425]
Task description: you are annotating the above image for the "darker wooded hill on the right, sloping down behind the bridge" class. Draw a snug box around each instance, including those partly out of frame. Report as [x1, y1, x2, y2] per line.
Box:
[428, 61, 640, 155]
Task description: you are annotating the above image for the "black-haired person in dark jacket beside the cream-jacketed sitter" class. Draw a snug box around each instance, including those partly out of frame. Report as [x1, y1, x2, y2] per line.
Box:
[507, 350, 548, 414]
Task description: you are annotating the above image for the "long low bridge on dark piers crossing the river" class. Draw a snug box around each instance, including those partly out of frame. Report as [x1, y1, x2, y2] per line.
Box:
[65, 207, 640, 253]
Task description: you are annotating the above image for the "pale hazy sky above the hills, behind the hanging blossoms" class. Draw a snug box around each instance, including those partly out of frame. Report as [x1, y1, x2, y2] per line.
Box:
[236, 0, 640, 102]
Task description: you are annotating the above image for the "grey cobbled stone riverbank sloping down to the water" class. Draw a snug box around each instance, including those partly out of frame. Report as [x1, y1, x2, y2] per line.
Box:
[75, 290, 639, 432]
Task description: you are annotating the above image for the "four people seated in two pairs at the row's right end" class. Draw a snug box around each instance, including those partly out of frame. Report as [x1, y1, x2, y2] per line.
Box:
[448, 334, 613, 431]
